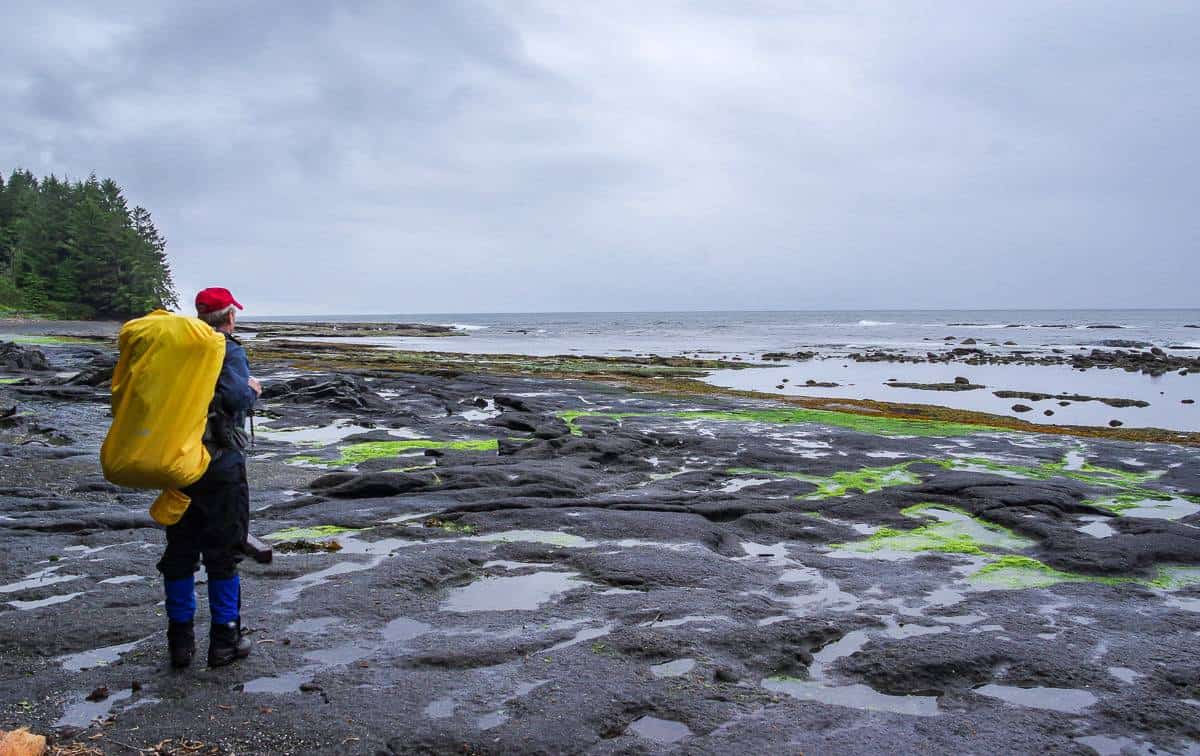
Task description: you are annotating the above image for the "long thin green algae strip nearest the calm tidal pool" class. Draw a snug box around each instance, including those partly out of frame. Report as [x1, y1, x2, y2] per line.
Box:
[558, 408, 996, 437]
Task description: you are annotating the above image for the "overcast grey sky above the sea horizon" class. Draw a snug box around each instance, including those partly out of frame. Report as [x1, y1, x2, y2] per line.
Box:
[0, 0, 1200, 314]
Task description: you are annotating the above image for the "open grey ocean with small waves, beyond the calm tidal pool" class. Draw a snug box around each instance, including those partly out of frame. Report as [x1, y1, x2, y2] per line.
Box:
[251, 310, 1200, 356]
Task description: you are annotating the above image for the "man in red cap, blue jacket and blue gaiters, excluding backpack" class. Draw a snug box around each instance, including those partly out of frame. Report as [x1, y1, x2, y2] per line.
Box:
[158, 288, 262, 668]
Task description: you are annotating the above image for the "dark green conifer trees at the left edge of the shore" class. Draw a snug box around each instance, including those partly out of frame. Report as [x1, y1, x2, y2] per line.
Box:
[0, 170, 179, 319]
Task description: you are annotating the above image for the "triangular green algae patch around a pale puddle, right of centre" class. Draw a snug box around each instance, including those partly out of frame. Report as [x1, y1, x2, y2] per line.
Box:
[833, 504, 1033, 556]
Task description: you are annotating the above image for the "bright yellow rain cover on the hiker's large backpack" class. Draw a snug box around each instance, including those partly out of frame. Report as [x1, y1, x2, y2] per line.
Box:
[100, 310, 226, 526]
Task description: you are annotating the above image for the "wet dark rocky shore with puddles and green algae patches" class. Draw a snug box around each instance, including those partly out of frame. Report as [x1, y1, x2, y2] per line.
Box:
[0, 333, 1200, 754]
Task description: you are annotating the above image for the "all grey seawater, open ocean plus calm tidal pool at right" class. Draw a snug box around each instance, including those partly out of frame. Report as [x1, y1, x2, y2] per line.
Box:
[248, 310, 1200, 431]
